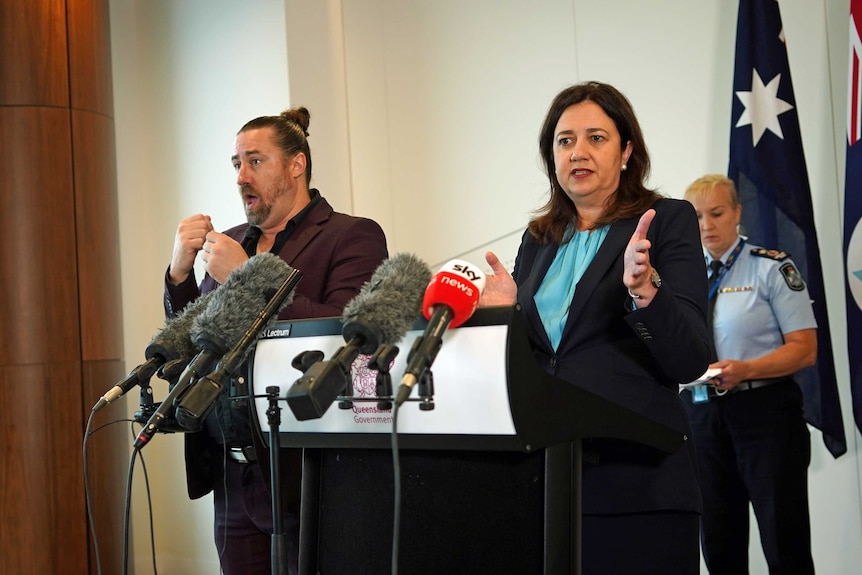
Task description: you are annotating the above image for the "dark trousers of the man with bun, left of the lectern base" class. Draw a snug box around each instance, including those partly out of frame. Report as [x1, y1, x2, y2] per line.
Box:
[213, 459, 299, 575]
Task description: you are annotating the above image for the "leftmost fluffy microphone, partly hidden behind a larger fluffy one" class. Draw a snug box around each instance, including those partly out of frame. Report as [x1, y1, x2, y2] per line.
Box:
[93, 294, 215, 413]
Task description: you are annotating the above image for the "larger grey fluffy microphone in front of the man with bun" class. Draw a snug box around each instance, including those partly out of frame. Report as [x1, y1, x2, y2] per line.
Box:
[134, 253, 301, 449]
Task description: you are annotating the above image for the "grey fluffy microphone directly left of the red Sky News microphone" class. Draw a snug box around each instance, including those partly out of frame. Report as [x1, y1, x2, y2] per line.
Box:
[287, 254, 431, 421]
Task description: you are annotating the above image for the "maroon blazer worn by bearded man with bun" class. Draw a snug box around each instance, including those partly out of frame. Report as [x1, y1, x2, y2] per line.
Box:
[164, 198, 388, 511]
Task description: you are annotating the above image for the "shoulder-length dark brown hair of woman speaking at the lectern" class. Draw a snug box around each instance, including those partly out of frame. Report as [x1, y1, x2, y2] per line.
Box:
[529, 82, 660, 243]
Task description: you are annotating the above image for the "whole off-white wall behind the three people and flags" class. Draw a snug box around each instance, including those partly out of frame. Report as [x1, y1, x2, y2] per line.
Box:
[111, 0, 862, 575]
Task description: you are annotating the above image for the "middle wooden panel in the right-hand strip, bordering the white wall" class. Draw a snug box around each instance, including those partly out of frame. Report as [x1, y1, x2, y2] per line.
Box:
[72, 110, 123, 361]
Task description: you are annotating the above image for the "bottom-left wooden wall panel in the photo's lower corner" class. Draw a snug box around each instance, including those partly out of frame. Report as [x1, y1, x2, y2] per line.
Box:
[0, 362, 88, 575]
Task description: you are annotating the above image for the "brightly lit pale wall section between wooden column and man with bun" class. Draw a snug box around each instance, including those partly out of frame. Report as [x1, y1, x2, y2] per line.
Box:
[111, 0, 290, 575]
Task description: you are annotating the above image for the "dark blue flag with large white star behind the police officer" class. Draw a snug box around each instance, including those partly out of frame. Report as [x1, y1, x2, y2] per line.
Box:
[728, 0, 848, 457]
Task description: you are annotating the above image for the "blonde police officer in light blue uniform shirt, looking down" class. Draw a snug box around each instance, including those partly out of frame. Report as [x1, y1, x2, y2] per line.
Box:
[682, 175, 817, 575]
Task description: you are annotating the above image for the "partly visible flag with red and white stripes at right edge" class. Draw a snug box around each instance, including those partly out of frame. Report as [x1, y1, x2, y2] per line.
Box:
[844, 0, 862, 431]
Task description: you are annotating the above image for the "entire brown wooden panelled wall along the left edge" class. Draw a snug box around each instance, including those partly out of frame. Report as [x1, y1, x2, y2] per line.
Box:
[0, 0, 125, 575]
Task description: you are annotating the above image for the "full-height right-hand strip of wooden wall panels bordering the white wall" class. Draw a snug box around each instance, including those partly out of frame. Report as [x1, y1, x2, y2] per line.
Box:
[67, 0, 128, 575]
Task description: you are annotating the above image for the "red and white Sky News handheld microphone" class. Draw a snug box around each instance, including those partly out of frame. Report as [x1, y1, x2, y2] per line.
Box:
[395, 260, 485, 406]
